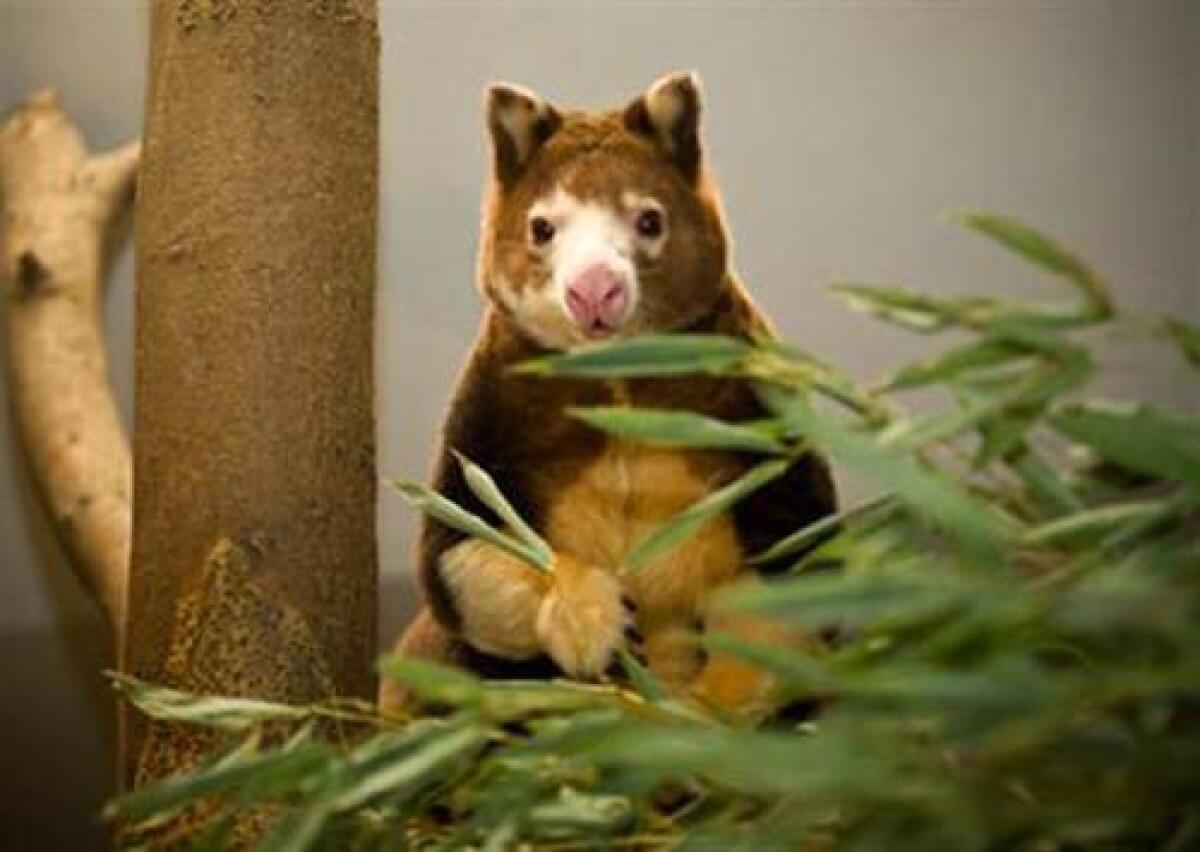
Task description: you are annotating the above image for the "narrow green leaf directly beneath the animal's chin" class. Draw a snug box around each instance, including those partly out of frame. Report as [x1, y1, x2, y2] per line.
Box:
[515, 335, 751, 378]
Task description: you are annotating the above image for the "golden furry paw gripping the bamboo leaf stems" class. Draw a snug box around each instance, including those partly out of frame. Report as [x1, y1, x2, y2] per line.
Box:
[538, 556, 630, 680]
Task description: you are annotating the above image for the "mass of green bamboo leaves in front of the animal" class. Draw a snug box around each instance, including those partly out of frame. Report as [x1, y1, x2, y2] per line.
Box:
[110, 215, 1200, 852]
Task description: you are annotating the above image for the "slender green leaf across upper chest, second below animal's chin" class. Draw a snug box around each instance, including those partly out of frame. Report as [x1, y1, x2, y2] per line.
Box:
[570, 406, 788, 454]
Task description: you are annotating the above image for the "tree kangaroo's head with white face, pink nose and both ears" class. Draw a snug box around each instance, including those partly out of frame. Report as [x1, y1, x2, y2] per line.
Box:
[480, 74, 727, 349]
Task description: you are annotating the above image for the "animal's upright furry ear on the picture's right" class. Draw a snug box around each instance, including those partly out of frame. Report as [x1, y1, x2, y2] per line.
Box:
[625, 71, 701, 180]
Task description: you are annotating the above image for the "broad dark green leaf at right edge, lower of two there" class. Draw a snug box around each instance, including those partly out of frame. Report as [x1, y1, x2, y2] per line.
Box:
[1050, 404, 1200, 487]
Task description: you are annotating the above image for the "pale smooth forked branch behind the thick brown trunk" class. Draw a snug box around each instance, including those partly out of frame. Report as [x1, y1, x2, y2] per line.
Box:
[0, 91, 138, 636]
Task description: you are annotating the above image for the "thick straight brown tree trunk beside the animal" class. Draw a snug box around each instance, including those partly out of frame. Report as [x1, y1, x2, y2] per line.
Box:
[122, 0, 378, 781]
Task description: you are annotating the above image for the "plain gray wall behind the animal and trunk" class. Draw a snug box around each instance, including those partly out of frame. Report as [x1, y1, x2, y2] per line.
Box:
[0, 0, 1200, 848]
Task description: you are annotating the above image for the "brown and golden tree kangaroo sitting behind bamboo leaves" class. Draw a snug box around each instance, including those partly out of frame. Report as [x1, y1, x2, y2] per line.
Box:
[383, 74, 834, 710]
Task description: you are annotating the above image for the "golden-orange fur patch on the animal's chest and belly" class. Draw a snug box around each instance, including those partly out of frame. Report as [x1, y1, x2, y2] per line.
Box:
[545, 439, 742, 614]
